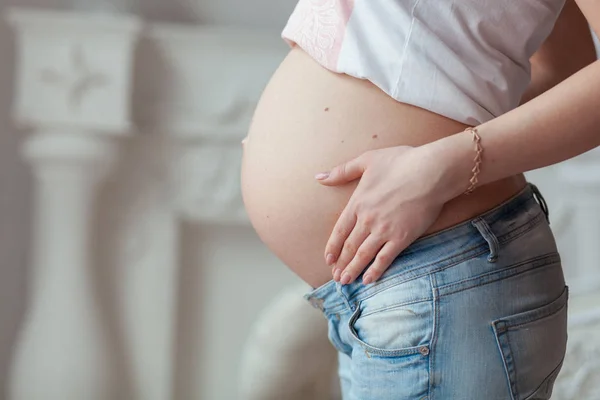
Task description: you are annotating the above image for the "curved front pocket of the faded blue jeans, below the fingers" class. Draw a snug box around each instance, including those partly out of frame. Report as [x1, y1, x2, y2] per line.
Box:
[348, 300, 434, 357]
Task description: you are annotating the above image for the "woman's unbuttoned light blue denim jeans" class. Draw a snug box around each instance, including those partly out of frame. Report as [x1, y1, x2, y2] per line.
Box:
[305, 185, 568, 400]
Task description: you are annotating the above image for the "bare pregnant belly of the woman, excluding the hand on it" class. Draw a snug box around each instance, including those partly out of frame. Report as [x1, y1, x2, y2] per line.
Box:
[242, 48, 524, 287]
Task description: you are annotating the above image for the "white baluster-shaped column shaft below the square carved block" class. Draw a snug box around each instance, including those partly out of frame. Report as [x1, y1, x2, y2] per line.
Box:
[10, 132, 118, 400]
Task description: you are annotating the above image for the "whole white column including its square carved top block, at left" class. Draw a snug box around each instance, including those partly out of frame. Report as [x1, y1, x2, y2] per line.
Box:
[8, 9, 139, 400]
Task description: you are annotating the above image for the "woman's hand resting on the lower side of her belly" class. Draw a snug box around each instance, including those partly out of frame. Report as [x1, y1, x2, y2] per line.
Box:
[316, 142, 469, 284]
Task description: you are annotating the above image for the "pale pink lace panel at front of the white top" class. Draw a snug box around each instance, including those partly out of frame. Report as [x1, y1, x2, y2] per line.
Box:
[282, 0, 354, 71]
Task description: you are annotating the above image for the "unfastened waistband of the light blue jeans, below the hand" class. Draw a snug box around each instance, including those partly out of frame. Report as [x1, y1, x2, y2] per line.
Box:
[304, 183, 548, 314]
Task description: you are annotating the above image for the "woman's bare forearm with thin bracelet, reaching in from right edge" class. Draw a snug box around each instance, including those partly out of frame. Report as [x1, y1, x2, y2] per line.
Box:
[432, 61, 600, 198]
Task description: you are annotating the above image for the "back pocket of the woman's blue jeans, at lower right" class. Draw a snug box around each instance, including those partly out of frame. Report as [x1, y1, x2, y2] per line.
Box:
[492, 287, 568, 400]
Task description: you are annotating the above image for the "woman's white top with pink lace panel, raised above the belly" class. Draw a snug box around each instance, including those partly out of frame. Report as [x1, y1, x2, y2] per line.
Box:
[282, 0, 565, 125]
